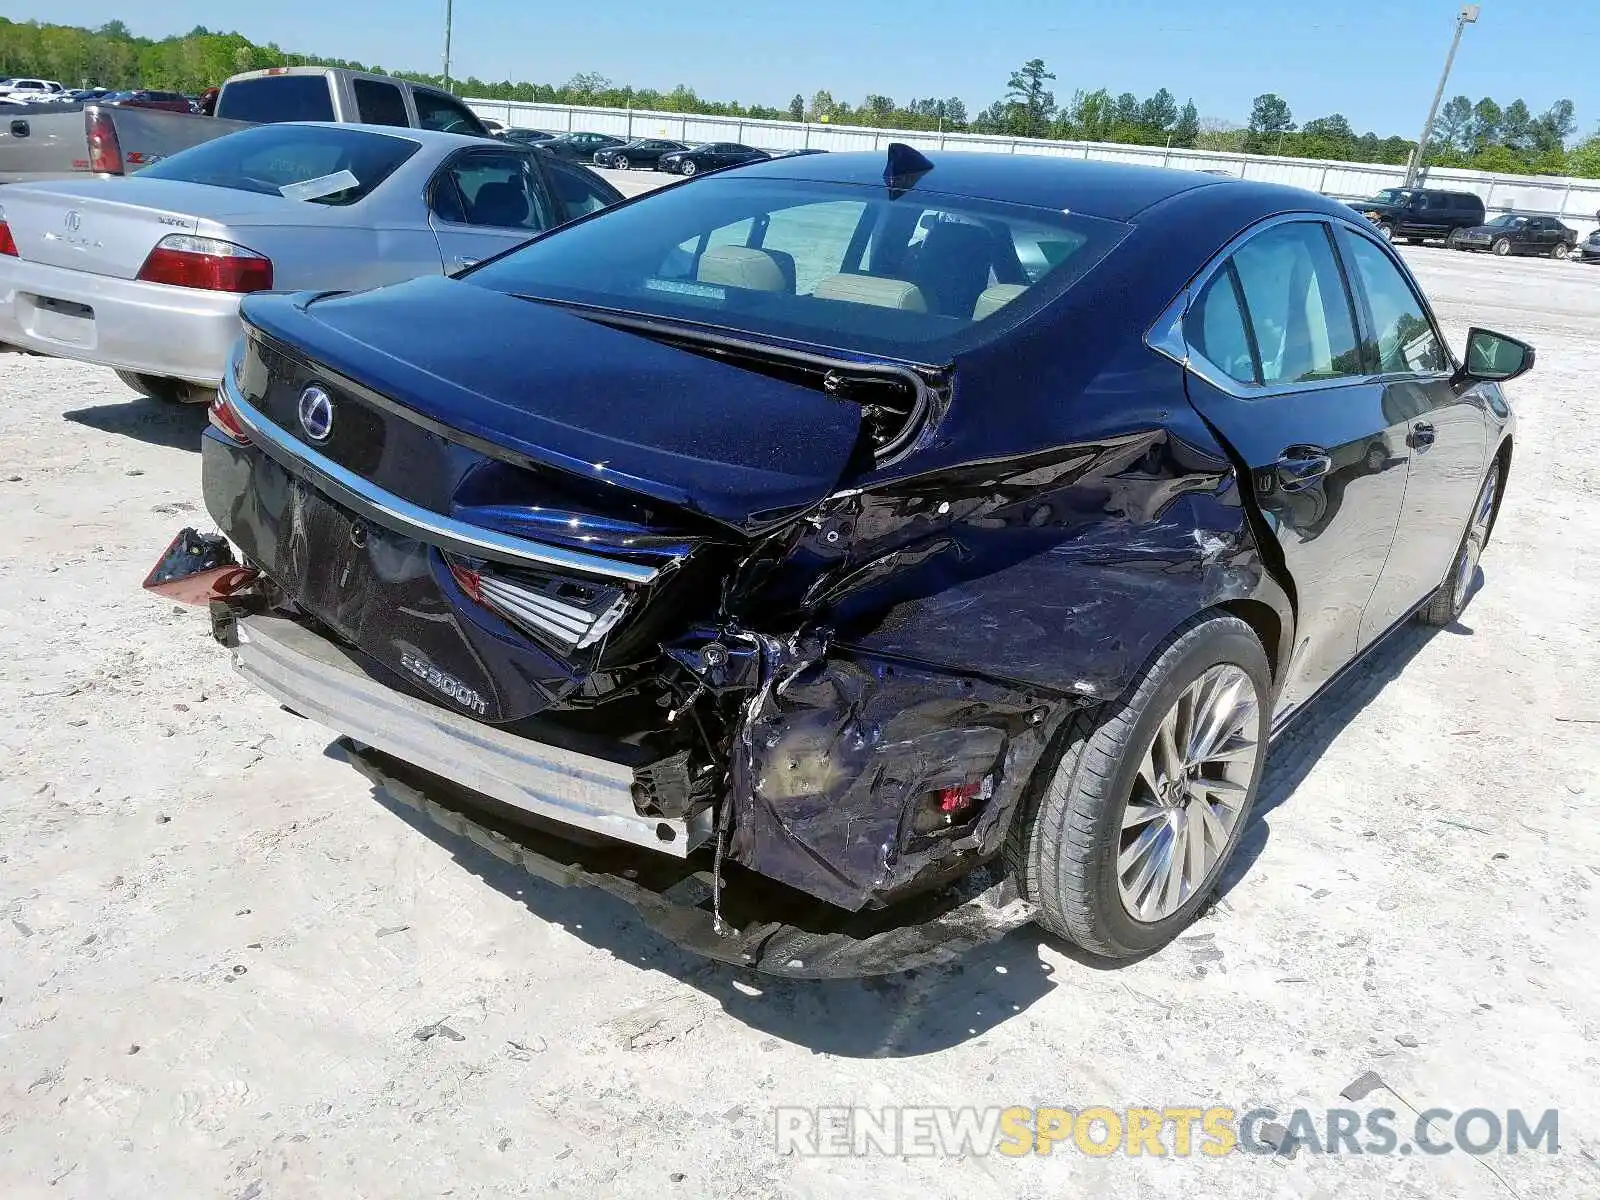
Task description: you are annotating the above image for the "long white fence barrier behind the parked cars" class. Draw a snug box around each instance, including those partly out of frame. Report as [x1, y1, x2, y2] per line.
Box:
[467, 99, 1600, 235]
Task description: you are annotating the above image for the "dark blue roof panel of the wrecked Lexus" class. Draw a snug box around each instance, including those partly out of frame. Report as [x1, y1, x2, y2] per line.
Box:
[736, 150, 1349, 221]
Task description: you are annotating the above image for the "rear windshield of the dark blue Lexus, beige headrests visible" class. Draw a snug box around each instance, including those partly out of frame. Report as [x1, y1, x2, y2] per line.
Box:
[466, 174, 1128, 362]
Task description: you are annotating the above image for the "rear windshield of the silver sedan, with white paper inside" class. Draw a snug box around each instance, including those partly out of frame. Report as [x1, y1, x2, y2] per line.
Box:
[139, 125, 421, 205]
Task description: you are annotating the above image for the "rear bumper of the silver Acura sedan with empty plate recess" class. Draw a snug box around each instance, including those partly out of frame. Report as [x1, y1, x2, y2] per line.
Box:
[0, 256, 240, 387]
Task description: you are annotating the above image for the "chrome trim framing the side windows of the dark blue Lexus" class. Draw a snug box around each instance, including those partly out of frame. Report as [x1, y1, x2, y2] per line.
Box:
[1144, 211, 1456, 400]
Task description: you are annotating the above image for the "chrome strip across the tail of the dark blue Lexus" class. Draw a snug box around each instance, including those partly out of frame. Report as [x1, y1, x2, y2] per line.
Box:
[222, 378, 664, 584]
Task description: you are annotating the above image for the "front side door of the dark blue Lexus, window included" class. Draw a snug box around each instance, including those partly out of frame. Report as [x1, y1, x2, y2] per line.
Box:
[1338, 226, 1488, 646]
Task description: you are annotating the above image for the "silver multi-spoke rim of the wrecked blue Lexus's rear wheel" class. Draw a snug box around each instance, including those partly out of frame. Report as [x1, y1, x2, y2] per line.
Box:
[1117, 662, 1261, 922]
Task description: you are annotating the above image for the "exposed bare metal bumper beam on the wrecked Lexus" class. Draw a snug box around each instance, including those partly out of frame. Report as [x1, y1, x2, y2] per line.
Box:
[234, 616, 712, 858]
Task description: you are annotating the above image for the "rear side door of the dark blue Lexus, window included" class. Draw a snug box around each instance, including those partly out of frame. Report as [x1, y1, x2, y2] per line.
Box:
[1182, 218, 1405, 714]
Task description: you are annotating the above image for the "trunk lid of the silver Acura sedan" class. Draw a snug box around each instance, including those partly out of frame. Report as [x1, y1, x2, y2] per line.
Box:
[3, 176, 284, 278]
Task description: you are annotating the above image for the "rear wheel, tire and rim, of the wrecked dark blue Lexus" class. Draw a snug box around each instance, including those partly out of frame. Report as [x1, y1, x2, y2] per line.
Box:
[1006, 613, 1272, 958]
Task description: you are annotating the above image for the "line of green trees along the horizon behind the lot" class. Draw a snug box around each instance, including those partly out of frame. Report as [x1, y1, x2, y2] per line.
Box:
[0, 18, 1600, 178]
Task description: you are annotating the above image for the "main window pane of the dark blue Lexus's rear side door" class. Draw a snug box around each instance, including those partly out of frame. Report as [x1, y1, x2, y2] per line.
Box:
[1232, 221, 1362, 387]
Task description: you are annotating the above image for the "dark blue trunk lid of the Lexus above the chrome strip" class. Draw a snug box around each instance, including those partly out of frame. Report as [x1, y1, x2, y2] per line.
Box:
[243, 277, 861, 536]
